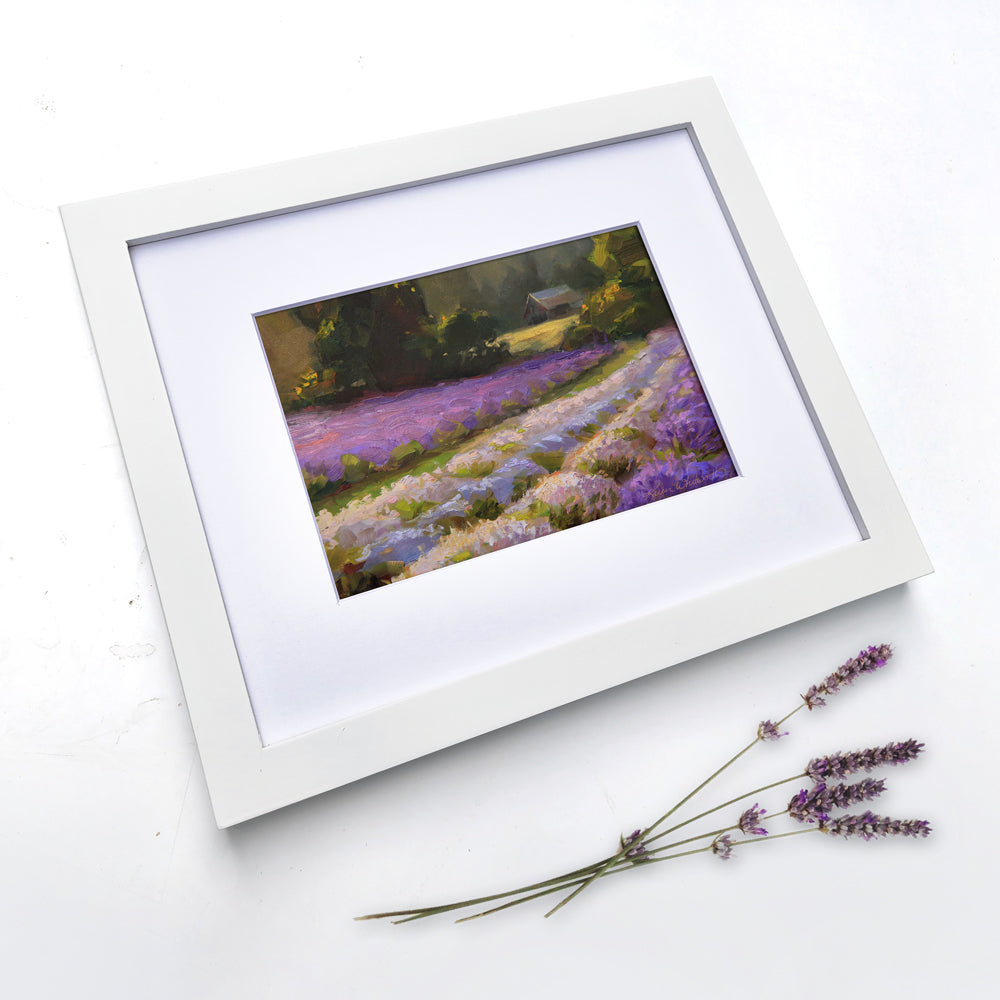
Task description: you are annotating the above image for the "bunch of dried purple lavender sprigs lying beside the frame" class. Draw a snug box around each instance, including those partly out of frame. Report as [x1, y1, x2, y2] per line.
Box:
[356, 645, 931, 923]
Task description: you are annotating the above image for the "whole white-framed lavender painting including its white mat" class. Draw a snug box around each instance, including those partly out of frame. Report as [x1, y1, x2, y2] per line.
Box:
[62, 80, 930, 826]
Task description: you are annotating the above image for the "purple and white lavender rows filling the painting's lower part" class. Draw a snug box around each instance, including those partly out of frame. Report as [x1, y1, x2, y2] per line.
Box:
[296, 328, 736, 597]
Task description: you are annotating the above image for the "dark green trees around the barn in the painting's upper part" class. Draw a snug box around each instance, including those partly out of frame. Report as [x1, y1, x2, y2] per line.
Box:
[278, 226, 670, 408]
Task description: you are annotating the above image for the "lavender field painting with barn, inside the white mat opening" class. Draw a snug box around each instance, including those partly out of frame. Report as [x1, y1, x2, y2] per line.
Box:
[256, 226, 736, 598]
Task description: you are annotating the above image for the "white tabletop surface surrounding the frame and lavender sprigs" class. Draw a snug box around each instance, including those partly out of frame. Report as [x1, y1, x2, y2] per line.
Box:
[0, 0, 1000, 998]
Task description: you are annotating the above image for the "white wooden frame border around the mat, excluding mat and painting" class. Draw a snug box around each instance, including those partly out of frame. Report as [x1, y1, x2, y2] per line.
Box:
[61, 79, 932, 827]
